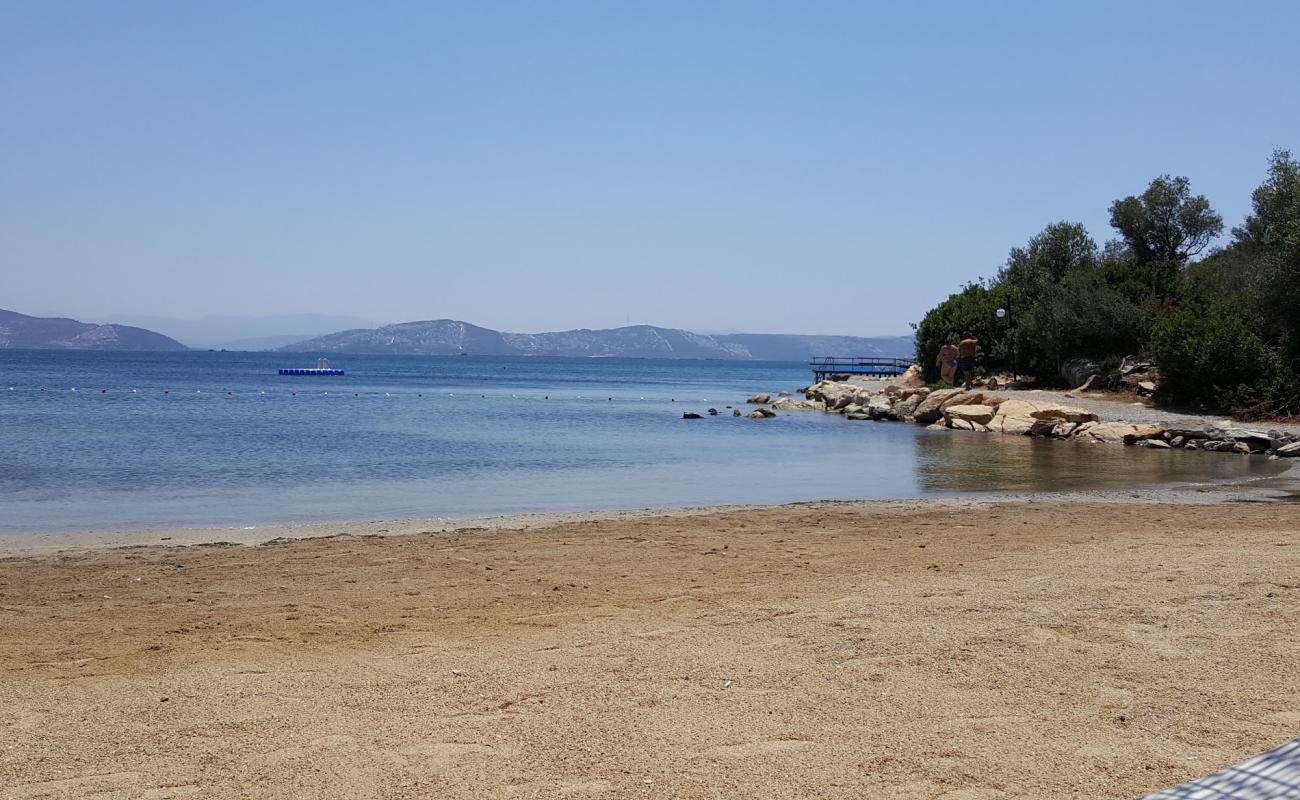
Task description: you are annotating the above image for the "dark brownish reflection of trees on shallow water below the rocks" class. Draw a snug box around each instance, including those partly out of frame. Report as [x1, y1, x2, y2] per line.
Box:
[915, 431, 1288, 493]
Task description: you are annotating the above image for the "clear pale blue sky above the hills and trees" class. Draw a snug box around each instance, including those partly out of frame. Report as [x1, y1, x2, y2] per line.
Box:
[0, 0, 1300, 336]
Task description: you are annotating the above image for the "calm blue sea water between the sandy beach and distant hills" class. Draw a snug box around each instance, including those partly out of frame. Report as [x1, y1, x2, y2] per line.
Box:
[0, 350, 1278, 532]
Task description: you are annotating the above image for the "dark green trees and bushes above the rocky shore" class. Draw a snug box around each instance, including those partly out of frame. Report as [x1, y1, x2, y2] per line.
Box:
[917, 150, 1300, 416]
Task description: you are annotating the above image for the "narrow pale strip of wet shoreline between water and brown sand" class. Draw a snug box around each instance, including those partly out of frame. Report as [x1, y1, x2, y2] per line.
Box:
[0, 464, 1300, 561]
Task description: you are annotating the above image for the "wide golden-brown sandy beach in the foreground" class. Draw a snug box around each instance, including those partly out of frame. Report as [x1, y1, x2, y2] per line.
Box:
[0, 502, 1300, 800]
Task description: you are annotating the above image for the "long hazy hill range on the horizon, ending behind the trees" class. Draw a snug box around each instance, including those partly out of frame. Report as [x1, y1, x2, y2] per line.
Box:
[280, 320, 914, 360]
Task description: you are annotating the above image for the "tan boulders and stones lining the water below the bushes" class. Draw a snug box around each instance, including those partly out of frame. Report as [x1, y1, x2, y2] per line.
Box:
[748, 367, 1300, 458]
